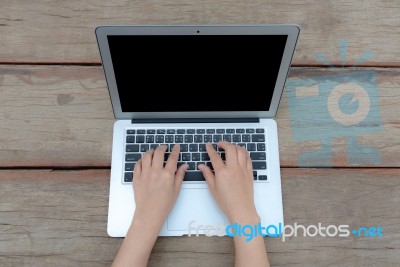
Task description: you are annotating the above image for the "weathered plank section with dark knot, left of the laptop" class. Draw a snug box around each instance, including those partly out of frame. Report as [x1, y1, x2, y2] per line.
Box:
[0, 66, 114, 166]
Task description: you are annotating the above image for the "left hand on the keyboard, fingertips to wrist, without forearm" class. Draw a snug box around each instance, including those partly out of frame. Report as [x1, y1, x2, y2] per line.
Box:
[133, 145, 188, 227]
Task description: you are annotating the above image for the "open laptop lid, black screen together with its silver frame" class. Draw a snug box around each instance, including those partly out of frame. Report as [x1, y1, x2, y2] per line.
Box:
[96, 25, 299, 119]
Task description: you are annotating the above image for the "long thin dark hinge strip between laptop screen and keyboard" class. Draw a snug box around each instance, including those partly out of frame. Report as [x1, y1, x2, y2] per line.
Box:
[132, 118, 260, 124]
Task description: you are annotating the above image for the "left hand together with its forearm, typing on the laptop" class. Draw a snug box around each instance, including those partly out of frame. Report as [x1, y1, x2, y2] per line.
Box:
[112, 148, 188, 266]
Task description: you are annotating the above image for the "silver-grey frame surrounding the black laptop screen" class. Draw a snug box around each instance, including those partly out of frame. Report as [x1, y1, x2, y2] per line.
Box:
[95, 25, 300, 119]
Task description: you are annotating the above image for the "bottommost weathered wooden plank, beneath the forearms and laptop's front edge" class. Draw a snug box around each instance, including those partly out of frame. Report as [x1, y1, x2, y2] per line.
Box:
[0, 168, 400, 267]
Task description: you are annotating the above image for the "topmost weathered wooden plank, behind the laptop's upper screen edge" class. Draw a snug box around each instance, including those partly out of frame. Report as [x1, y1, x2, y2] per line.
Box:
[0, 0, 400, 66]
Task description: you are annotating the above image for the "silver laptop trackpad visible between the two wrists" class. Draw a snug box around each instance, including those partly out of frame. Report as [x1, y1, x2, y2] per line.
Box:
[167, 188, 228, 231]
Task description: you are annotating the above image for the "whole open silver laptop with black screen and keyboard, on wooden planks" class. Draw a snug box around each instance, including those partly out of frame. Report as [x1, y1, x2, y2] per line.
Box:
[96, 25, 299, 237]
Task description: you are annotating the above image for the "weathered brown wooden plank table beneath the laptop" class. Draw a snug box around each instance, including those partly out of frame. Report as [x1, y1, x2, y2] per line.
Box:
[0, 0, 400, 266]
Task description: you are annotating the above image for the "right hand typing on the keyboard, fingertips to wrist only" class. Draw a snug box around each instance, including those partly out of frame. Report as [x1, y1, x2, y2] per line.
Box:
[199, 141, 260, 223]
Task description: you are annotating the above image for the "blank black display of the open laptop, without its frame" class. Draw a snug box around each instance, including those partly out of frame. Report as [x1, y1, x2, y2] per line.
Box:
[107, 35, 287, 112]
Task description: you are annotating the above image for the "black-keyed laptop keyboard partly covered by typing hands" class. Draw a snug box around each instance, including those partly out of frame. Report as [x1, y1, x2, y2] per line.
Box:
[123, 128, 268, 183]
